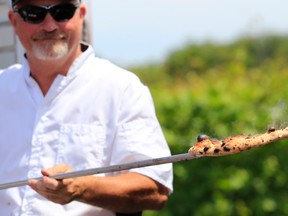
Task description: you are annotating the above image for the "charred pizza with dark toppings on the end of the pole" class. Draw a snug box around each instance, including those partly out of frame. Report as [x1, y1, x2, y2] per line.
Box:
[188, 127, 288, 157]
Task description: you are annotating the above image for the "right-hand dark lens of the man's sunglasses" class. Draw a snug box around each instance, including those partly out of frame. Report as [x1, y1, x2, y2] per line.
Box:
[50, 4, 77, 22]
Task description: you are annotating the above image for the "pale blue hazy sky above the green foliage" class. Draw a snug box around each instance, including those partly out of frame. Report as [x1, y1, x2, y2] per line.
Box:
[91, 0, 288, 67]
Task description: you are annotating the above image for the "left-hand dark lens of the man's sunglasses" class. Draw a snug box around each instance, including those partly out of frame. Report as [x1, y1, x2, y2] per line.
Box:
[19, 5, 47, 23]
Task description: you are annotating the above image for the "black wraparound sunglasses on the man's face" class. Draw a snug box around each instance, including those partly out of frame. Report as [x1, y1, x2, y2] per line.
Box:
[13, 3, 79, 24]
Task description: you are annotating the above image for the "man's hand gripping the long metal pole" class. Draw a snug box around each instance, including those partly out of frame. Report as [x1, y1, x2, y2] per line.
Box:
[28, 164, 79, 204]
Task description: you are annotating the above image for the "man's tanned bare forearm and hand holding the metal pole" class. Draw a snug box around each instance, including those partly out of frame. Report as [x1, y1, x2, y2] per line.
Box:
[28, 164, 169, 213]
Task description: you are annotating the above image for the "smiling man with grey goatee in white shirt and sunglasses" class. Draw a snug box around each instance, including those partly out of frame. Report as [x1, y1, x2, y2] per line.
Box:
[0, 0, 172, 216]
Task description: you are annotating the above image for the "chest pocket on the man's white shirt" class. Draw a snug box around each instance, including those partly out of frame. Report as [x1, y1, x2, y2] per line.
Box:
[56, 124, 105, 170]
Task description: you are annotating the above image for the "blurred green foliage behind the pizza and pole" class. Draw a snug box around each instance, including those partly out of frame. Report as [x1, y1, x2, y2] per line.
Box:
[131, 36, 288, 216]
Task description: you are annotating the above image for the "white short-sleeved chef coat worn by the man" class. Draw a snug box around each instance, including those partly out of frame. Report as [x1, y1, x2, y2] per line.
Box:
[0, 45, 172, 216]
